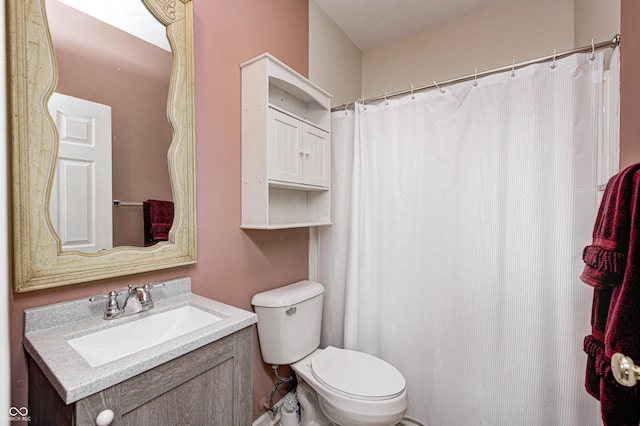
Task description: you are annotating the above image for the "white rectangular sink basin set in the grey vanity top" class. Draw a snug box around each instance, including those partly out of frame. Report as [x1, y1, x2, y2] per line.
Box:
[67, 306, 222, 367]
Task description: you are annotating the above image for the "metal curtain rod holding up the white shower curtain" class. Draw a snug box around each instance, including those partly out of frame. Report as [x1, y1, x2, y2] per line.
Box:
[331, 34, 620, 112]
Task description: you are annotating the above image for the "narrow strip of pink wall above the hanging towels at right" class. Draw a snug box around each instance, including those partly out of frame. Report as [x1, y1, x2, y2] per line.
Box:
[620, 0, 640, 170]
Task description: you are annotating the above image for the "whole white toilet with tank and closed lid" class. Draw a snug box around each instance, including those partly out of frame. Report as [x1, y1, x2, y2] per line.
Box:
[251, 280, 408, 426]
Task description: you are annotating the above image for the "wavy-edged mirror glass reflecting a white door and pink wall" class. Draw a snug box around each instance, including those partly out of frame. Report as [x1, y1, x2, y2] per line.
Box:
[46, 0, 173, 253]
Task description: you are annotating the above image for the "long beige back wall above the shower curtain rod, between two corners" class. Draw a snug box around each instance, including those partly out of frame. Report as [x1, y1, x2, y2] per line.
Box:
[362, 0, 574, 97]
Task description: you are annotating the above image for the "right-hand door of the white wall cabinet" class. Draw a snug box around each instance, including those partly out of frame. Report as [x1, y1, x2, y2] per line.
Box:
[302, 124, 331, 187]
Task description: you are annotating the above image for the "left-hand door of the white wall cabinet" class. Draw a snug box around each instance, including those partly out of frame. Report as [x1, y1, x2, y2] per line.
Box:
[267, 108, 304, 183]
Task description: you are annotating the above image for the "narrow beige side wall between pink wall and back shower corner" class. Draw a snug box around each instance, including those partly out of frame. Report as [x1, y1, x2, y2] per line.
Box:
[309, 0, 362, 105]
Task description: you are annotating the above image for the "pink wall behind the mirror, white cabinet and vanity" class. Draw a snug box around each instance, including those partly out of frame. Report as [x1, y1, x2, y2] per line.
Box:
[9, 0, 308, 417]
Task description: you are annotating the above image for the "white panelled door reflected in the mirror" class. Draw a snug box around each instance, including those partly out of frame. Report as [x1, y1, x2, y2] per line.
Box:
[49, 93, 113, 253]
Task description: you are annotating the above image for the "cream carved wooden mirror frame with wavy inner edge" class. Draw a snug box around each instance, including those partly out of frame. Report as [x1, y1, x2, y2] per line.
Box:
[7, 0, 197, 292]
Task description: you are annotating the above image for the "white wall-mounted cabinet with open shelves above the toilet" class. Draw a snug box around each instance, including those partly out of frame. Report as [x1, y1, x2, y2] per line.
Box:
[241, 53, 331, 229]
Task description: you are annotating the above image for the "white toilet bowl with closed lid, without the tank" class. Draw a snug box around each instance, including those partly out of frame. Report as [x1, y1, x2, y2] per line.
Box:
[291, 346, 408, 426]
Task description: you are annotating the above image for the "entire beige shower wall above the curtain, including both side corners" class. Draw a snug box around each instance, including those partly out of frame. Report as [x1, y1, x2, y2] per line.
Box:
[309, 0, 620, 106]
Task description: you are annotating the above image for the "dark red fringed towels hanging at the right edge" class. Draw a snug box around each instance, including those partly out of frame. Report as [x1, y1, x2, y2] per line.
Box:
[580, 164, 640, 426]
